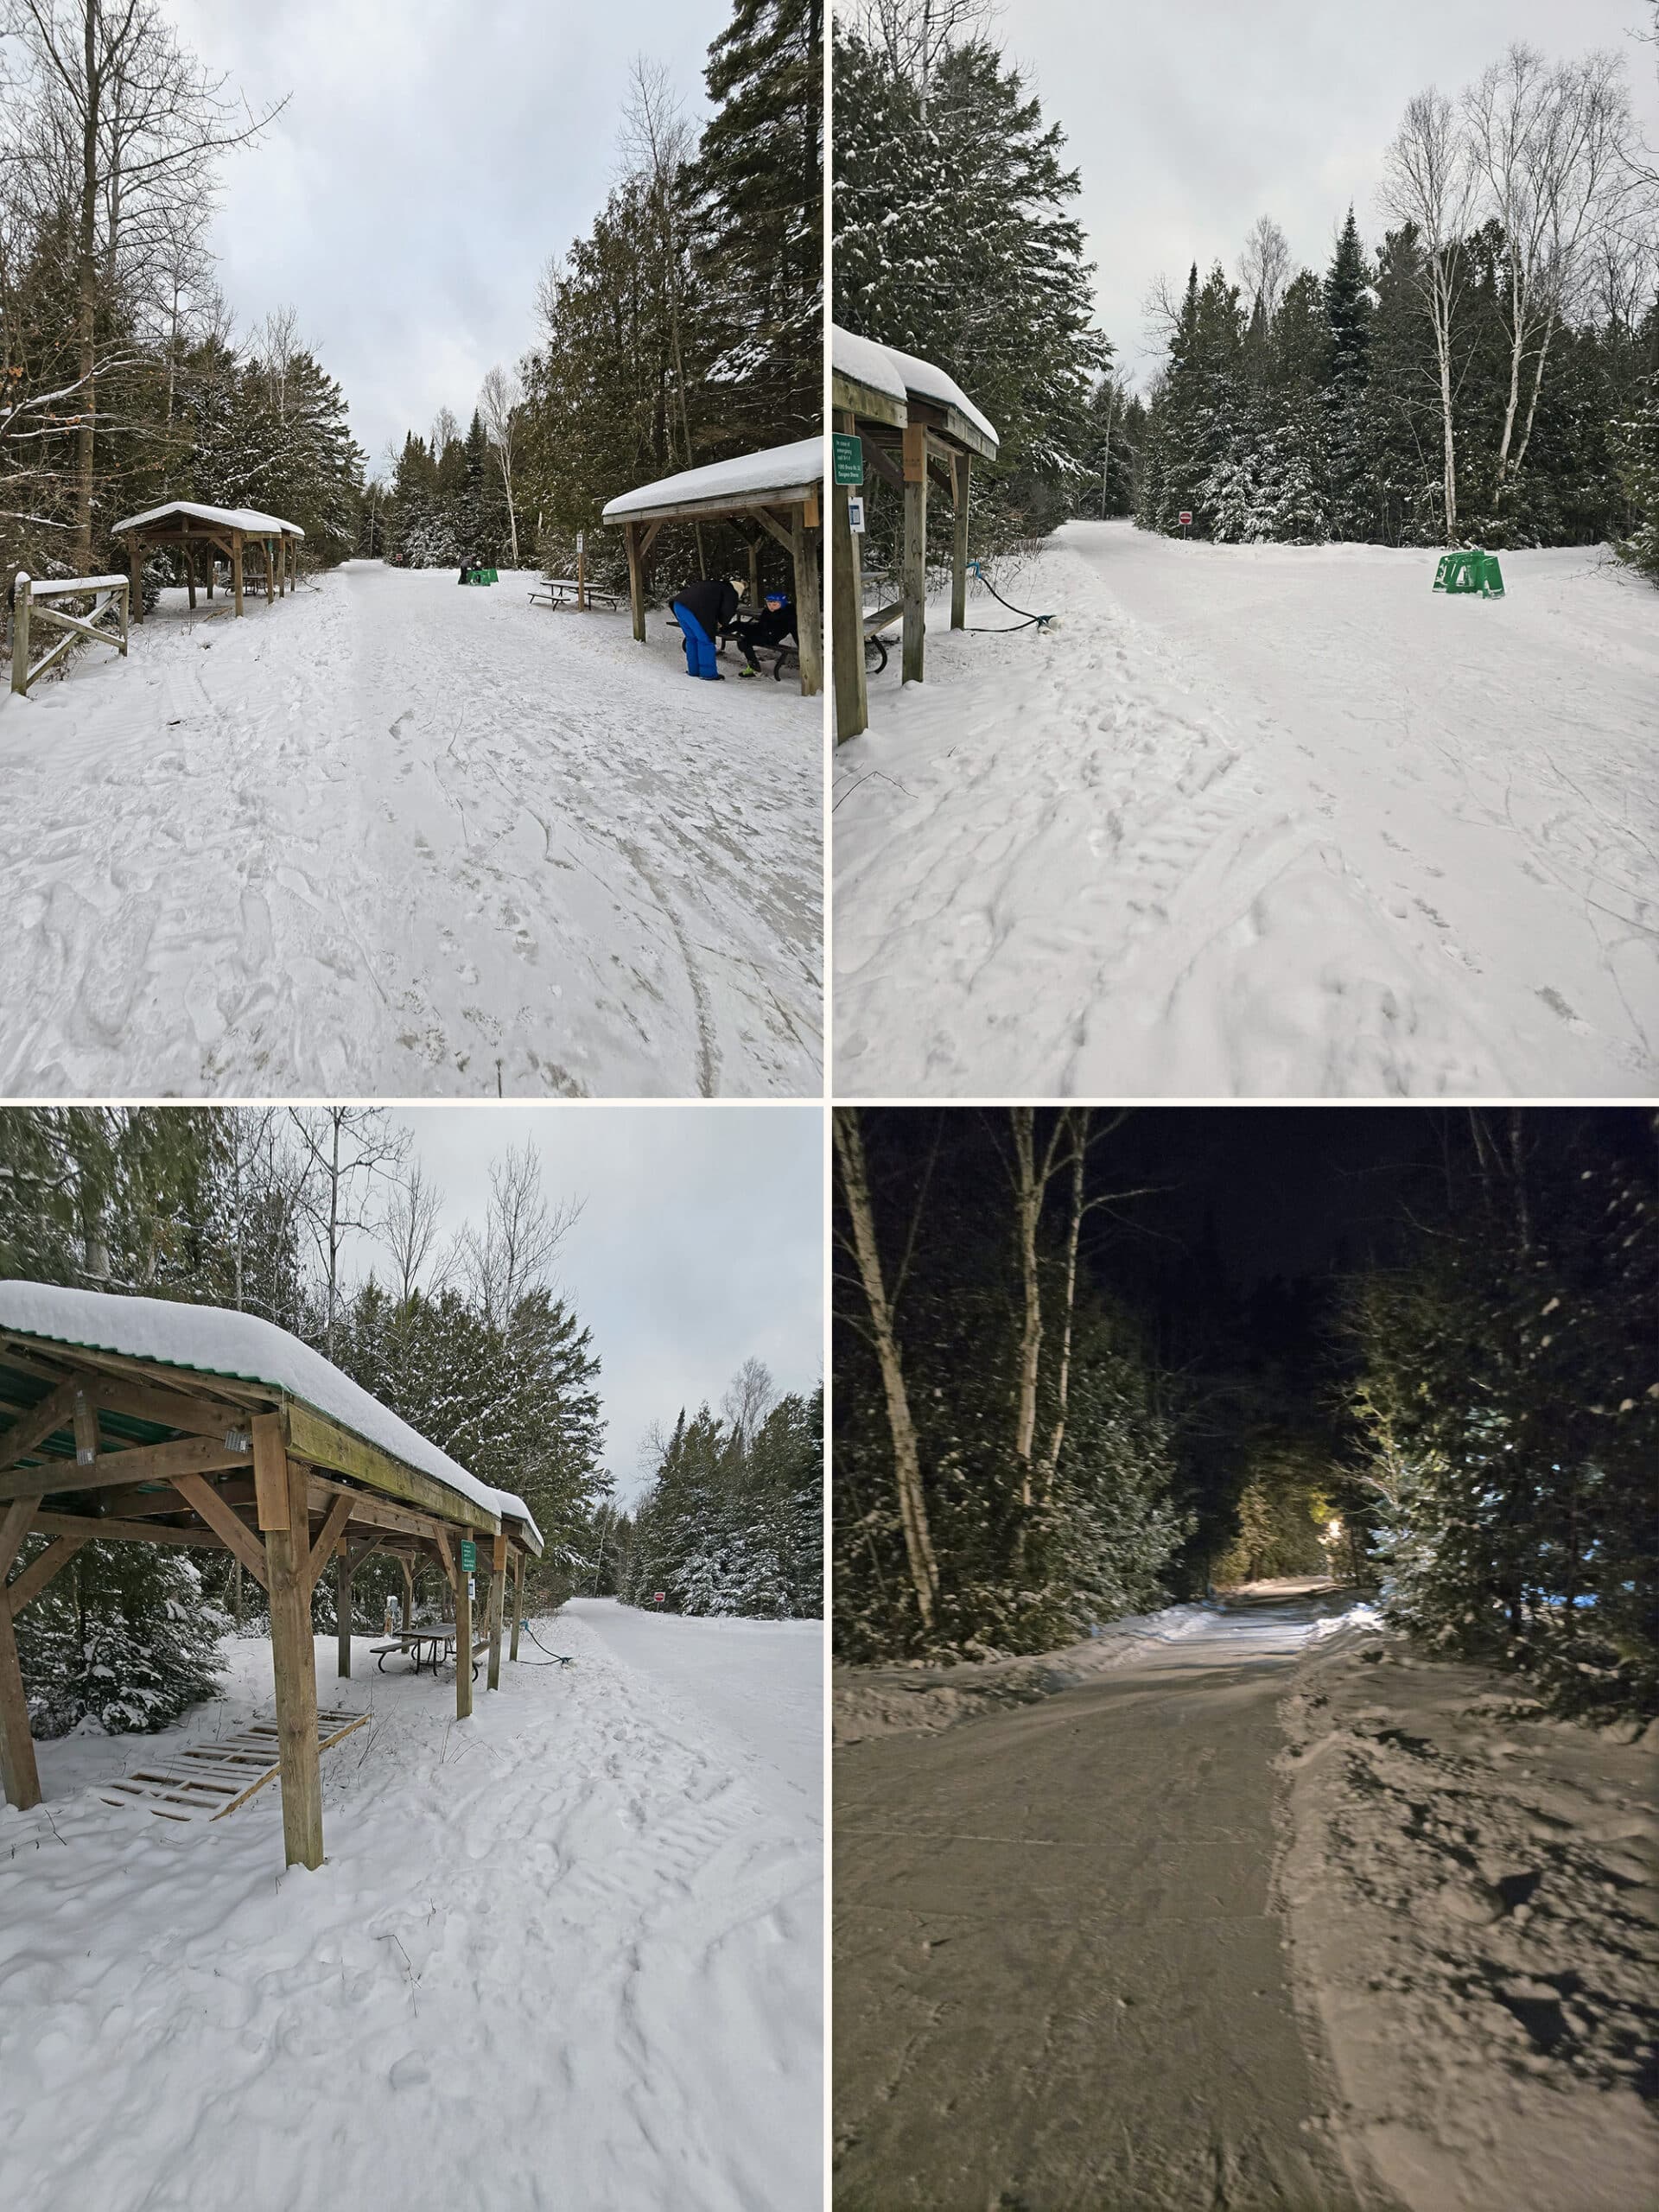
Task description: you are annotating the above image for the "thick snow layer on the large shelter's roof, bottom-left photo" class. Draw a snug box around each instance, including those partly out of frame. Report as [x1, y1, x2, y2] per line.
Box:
[0, 1283, 542, 1544]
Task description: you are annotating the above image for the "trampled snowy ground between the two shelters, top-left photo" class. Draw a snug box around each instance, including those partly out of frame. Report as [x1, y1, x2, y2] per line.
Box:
[0, 562, 823, 1097]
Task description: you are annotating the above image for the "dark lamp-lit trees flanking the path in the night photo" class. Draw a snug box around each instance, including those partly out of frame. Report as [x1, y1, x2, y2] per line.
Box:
[832, 1109, 1659, 1710]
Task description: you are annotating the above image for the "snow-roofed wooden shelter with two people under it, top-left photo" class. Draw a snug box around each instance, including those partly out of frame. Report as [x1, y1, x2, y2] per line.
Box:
[604, 438, 823, 699]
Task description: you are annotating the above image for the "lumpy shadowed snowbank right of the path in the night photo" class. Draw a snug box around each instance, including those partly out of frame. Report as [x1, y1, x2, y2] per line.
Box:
[1279, 1617, 1659, 2212]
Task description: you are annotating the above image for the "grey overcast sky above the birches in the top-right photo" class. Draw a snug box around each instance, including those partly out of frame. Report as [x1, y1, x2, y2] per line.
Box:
[998, 0, 1659, 385]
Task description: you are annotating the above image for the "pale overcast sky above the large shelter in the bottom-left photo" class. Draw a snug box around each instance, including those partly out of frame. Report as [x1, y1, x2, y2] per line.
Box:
[336, 1103, 823, 1500]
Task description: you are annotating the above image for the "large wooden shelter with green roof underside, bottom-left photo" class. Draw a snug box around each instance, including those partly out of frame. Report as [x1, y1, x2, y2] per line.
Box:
[0, 1283, 542, 1867]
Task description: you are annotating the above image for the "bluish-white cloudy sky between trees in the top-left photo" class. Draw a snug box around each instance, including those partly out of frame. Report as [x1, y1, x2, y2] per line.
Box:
[168, 0, 730, 467]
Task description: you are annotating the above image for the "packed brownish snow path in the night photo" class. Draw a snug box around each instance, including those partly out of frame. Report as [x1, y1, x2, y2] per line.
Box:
[834, 1595, 1380, 2212]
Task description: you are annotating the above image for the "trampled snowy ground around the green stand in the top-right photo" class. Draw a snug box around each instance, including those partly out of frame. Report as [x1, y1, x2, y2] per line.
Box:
[834, 522, 1659, 1097]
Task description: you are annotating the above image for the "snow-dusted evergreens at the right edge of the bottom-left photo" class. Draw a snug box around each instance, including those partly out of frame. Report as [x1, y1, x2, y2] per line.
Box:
[595, 1360, 823, 1619]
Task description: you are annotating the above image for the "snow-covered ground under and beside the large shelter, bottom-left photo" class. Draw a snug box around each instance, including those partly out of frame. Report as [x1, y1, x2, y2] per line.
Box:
[0, 1606, 823, 2212]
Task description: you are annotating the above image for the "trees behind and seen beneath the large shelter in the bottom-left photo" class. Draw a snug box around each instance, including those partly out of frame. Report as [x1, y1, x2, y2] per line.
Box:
[0, 1106, 611, 1734]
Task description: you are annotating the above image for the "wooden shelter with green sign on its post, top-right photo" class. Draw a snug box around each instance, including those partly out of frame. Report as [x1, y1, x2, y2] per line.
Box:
[830, 325, 998, 739]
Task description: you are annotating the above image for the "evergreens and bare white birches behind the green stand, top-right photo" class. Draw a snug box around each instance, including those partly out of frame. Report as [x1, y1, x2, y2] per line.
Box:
[1135, 44, 1659, 564]
